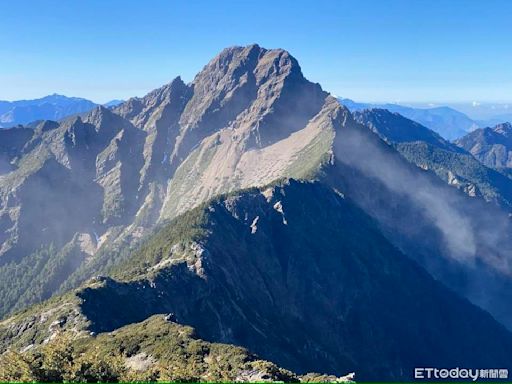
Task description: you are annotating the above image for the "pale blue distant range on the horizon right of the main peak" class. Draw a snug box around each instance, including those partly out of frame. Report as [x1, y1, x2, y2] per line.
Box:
[339, 98, 479, 140]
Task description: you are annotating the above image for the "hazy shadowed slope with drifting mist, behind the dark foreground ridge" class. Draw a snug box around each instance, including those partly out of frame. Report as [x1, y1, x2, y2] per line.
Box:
[327, 113, 512, 327]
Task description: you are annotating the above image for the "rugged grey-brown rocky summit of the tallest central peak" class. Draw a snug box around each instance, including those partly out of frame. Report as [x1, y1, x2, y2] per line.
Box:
[173, 45, 327, 158]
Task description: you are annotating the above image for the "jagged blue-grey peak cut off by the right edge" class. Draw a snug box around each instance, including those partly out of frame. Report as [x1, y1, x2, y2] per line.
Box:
[455, 123, 512, 169]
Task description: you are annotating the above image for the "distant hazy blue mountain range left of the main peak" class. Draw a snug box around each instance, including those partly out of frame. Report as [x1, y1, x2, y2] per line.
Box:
[0, 94, 122, 128]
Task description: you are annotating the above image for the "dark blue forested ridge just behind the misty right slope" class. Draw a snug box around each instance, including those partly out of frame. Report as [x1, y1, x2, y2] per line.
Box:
[354, 109, 512, 210]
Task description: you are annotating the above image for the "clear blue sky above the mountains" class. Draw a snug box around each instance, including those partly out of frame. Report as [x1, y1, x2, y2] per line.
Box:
[0, 0, 512, 102]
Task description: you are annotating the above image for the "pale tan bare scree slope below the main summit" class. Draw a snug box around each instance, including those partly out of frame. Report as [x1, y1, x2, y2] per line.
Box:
[161, 98, 340, 219]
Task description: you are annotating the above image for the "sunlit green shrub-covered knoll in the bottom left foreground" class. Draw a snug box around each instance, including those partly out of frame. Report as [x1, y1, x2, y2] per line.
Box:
[0, 316, 299, 382]
